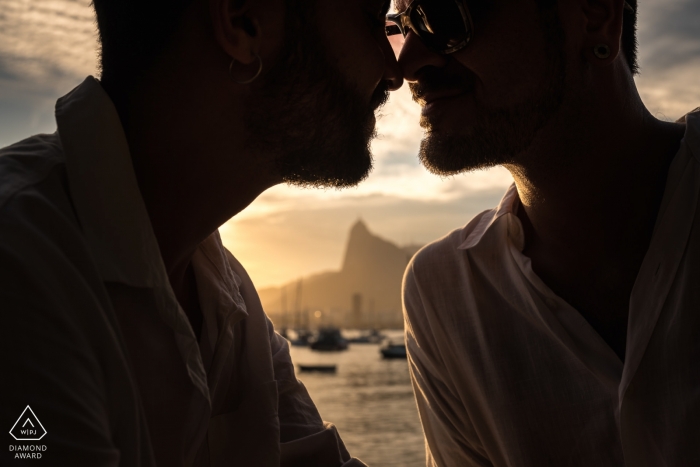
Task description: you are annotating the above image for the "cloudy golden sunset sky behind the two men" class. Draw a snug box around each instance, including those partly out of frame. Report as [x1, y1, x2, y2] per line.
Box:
[0, 0, 700, 288]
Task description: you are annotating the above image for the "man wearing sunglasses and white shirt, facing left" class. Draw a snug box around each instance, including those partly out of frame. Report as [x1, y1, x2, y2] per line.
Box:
[394, 0, 700, 467]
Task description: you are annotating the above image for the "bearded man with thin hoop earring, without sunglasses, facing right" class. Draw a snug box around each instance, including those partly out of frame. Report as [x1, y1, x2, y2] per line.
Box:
[0, 0, 402, 467]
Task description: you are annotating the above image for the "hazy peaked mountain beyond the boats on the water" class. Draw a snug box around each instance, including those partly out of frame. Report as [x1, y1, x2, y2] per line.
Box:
[259, 220, 420, 327]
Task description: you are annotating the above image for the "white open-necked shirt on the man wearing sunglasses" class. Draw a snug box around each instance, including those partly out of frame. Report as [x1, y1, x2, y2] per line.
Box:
[403, 108, 700, 467]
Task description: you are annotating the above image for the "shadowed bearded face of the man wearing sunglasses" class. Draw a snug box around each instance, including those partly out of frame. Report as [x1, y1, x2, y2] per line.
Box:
[397, 0, 566, 175]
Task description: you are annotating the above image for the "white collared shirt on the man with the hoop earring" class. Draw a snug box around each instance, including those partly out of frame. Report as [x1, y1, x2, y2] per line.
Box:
[0, 77, 364, 467]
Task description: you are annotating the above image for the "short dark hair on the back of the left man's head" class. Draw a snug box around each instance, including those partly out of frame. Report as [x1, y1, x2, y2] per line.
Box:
[92, 0, 192, 87]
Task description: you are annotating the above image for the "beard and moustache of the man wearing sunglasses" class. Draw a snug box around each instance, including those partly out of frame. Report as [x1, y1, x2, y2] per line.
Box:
[409, 6, 566, 176]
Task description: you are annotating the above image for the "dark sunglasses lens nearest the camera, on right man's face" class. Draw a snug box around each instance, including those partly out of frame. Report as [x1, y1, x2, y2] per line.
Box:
[411, 0, 471, 52]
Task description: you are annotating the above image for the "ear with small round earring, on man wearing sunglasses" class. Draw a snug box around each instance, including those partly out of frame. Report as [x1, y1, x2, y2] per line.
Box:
[578, 0, 625, 65]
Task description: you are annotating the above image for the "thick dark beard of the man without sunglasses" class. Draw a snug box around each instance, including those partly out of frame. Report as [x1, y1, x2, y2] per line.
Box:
[247, 0, 389, 188]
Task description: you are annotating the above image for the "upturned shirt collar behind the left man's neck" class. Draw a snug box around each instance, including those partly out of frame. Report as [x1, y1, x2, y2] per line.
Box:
[56, 76, 165, 287]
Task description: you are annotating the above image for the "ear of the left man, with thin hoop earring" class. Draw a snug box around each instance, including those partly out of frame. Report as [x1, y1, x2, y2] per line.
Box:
[209, 0, 261, 65]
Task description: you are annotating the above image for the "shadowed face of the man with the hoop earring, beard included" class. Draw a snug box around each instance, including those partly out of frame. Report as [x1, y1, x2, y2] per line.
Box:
[248, 0, 402, 188]
